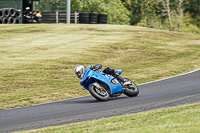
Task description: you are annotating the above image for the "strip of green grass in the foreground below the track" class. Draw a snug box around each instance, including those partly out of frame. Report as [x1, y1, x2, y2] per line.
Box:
[16, 103, 200, 133]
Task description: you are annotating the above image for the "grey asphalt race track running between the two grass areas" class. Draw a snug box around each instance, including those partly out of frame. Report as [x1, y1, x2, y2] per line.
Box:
[0, 69, 200, 133]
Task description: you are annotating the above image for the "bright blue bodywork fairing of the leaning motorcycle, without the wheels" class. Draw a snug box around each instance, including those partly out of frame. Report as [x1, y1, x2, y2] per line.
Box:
[80, 66, 125, 94]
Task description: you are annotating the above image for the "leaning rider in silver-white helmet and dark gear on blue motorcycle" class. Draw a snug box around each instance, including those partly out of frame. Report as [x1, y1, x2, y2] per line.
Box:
[74, 64, 125, 85]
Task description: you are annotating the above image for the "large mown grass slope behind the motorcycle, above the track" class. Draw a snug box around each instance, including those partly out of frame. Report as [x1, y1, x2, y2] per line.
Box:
[0, 24, 200, 110]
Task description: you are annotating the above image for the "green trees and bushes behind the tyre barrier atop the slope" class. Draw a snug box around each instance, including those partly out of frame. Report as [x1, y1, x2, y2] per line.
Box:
[40, 0, 200, 33]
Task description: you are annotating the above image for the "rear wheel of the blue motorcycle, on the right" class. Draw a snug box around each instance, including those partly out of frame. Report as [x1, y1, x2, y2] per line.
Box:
[124, 79, 139, 97]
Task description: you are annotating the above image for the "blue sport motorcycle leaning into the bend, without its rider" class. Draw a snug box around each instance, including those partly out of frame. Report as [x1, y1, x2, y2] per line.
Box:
[80, 66, 139, 101]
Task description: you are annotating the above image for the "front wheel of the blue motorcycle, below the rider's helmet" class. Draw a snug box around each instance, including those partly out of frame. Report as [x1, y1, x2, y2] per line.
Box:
[88, 85, 110, 101]
